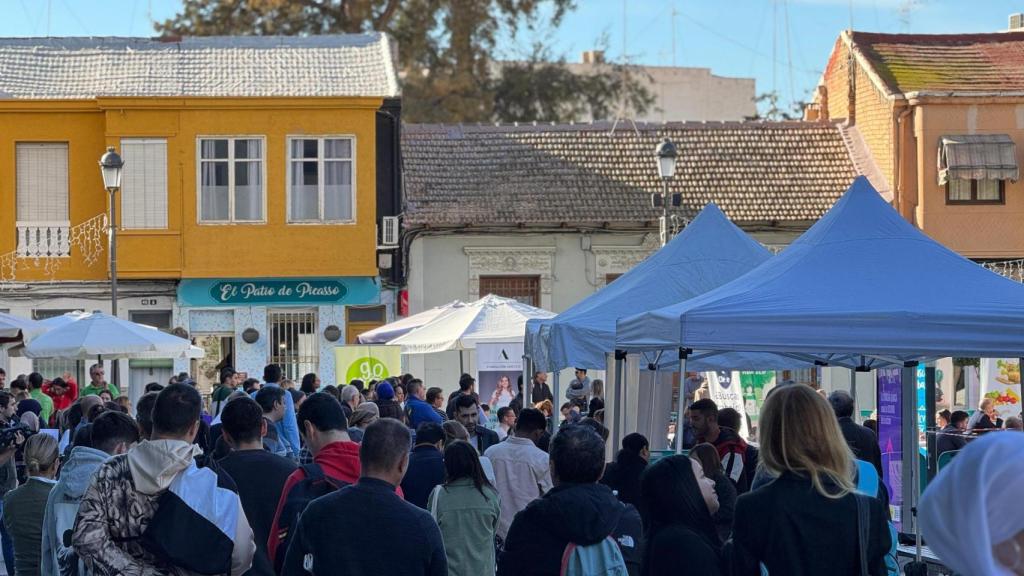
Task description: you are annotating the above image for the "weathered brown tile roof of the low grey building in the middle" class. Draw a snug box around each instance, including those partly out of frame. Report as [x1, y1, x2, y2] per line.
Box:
[402, 122, 856, 227]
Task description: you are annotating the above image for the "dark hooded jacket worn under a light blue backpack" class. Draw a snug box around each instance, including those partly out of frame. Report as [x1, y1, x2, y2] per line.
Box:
[498, 484, 642, 576]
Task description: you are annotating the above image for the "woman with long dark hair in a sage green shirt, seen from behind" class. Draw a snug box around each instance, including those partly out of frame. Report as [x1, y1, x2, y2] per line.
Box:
[427, 440, 501, 576]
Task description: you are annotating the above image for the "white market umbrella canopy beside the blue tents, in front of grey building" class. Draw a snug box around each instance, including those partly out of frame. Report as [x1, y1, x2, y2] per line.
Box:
[388, 294, 555, 354]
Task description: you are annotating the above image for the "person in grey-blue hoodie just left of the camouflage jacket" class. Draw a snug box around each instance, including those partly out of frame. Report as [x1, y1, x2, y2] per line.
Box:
[39, 411, 139, 576]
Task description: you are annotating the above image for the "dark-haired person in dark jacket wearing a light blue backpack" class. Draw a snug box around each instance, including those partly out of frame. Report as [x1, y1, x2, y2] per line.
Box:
[498, 422, 641, 576]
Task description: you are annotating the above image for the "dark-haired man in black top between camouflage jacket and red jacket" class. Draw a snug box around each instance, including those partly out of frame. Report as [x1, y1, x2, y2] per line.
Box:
[219, 397, 296, 576]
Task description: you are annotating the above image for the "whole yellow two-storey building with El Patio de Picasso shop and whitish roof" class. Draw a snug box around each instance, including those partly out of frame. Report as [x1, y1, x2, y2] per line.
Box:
[0, 34, 400, 392]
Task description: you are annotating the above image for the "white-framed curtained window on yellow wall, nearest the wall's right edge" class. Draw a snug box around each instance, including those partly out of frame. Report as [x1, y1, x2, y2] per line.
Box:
[288, 137, 355, 222]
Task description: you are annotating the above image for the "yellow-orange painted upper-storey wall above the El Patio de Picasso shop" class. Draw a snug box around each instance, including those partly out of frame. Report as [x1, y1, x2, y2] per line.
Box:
[0, 98, 381, 281]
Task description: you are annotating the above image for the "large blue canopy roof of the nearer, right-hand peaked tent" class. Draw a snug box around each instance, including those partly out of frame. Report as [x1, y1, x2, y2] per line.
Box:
[616, 177, 1024, 366]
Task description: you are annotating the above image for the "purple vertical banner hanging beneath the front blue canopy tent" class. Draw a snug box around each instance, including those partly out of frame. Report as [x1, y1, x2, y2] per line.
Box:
[878, 368, 903, 531]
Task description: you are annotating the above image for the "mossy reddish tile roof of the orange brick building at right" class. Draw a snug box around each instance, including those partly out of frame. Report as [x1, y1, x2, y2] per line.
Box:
[845, 32, 1024, 94]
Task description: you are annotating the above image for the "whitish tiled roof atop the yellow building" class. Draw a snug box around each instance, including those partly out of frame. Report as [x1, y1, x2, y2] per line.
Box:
[0, 33, 399, 99]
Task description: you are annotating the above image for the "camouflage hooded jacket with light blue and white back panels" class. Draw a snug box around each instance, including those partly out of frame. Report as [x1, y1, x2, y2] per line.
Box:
[72, 440, 256, 576]
